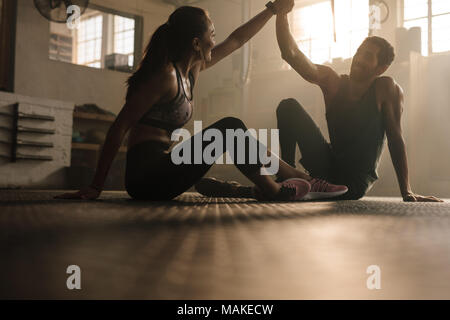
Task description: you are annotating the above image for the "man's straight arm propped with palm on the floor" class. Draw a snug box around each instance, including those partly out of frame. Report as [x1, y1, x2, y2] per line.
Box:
[377, 77, 442, 202]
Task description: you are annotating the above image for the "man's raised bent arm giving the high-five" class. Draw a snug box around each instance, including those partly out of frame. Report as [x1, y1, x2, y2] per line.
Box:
[276, 14, 339, 91]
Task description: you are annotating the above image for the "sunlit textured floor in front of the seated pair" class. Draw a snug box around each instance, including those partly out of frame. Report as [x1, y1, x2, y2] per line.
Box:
[0, 190, 450, 299]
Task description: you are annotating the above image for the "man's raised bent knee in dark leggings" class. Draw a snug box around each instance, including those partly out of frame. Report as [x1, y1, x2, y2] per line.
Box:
[276, 98, 331, 179]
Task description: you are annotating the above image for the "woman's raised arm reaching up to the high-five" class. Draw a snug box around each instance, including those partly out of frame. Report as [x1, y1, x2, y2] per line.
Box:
[202, 0, 294, 70]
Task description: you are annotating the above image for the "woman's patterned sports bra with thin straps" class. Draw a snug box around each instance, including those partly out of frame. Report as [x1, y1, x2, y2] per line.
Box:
[138, 63, 195, 132]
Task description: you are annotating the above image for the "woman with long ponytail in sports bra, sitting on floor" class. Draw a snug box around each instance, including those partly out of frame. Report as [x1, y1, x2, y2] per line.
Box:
[57, 0, 347, 200]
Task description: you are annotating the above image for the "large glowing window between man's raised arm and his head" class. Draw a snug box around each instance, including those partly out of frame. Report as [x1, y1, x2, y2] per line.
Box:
[292, 0, 369, 63]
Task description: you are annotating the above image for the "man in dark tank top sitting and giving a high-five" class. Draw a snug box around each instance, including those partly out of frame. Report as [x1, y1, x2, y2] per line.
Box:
[197, 6, 442, 202]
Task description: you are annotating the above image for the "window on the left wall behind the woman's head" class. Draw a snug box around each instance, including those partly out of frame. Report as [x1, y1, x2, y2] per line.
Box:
[49, 5, 142, 72]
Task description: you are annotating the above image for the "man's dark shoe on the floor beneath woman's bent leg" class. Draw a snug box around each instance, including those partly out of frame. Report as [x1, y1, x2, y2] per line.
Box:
[195, 178, 255, 198]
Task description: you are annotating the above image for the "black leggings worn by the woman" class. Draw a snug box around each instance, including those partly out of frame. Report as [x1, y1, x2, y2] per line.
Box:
[125, 117, 266, 200]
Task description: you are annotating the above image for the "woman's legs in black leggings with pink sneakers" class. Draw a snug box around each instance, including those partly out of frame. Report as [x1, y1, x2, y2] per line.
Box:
[127, 117, 338, 200]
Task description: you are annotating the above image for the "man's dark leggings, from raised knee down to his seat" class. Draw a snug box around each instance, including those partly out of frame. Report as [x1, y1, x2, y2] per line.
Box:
[277, 99, 370, 200]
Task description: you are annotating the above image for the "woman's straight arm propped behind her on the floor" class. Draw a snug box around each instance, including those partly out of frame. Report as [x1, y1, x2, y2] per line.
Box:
[55, 74, 177, 199]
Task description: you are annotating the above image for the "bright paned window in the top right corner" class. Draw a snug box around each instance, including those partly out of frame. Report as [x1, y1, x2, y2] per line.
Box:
[403, 0, 450, 56]
